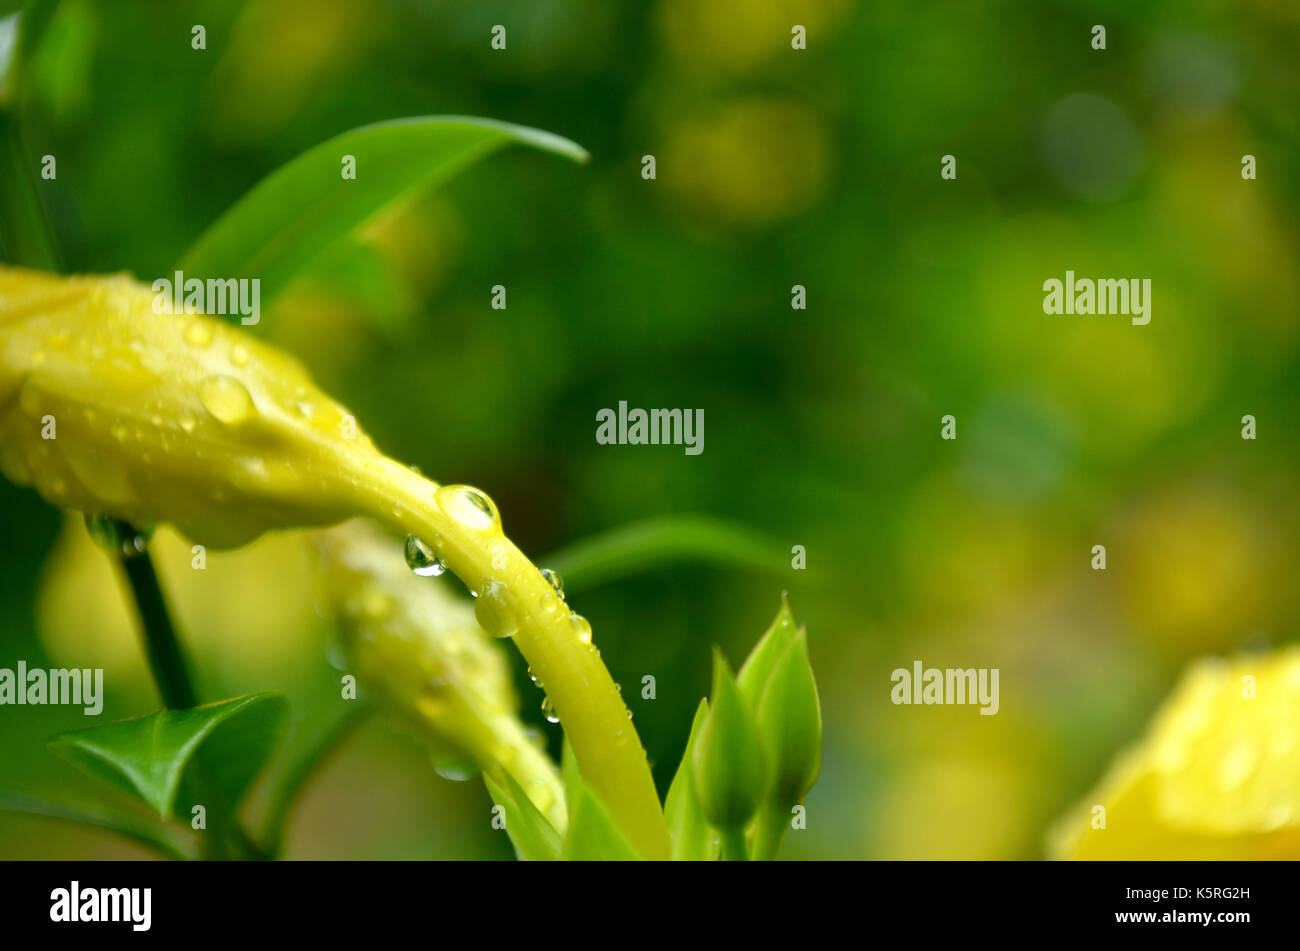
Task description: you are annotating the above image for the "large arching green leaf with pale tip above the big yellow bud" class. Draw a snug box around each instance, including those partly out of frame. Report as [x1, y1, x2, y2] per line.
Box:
[176, 116, 588, 317]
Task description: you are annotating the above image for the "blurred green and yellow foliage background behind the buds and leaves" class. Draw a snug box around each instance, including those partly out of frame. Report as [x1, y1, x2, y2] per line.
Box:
[0, 0, 1300, 857]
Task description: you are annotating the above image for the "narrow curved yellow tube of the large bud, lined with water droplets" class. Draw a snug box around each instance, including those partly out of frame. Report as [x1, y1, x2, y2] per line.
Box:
[352, 462, 671, 859]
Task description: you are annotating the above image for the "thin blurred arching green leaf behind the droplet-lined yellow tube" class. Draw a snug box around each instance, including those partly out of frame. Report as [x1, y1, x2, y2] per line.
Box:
[540, 516, 789, 594]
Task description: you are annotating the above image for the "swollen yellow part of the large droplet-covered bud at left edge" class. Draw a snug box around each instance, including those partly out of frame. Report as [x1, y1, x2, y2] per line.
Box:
[0, 268, 378, 548]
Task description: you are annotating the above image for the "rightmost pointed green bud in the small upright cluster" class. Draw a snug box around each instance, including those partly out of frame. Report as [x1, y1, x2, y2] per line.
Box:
[757, 630, 822, 812]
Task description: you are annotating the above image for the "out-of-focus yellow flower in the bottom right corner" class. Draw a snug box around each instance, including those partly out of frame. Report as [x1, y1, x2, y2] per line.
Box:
[1048, 647, 1300, 859]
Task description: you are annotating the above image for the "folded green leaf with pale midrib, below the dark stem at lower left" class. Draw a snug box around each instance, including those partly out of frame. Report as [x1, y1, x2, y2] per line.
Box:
[49, 694, 286, 818]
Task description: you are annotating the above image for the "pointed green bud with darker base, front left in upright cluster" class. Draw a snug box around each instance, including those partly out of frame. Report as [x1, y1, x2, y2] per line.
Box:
[690, 650, 771, 836]
